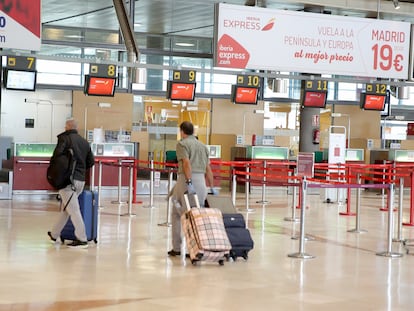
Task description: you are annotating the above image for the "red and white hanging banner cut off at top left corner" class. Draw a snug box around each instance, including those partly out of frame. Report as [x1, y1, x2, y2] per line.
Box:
[0, 0, 41, 51]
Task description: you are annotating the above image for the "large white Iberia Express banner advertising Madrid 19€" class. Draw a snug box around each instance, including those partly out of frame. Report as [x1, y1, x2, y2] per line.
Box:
[215, 4, 410, 79]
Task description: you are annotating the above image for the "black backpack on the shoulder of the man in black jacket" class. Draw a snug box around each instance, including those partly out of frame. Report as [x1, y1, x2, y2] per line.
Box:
[46, 142, 76, 190]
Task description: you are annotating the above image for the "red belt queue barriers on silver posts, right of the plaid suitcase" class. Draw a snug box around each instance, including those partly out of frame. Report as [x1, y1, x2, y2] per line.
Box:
[215, 161, 414, 258]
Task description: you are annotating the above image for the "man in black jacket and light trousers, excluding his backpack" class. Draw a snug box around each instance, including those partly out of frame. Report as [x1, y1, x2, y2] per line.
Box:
[47, 119, 95, 248]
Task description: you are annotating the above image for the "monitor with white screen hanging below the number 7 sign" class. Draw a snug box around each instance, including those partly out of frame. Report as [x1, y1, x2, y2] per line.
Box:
[3, 68, 37, 91]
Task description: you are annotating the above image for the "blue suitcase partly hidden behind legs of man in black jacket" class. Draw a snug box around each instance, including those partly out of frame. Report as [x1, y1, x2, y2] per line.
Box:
[60, 190, 98, 243]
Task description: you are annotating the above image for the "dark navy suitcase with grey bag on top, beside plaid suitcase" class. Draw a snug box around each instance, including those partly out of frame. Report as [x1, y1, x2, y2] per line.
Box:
[207, 196, 254, 260]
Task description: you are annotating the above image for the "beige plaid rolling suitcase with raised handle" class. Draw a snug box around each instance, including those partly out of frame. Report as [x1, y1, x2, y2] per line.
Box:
[181, 194, 231, 265]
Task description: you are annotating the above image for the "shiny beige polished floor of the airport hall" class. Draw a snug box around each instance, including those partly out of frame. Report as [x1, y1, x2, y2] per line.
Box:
[0, 189, 414, 311]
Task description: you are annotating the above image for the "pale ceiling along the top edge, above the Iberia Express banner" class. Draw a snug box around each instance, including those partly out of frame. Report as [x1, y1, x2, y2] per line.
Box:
[42, 0, 414, 38]
